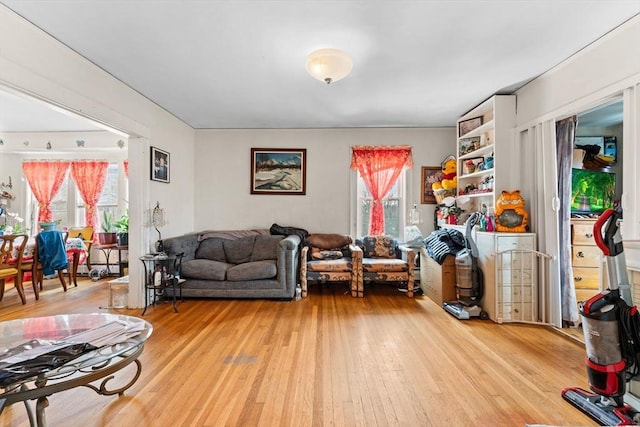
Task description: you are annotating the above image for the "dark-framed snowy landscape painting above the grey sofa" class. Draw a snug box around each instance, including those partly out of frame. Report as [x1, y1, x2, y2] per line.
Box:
[251, 148, 307, 195]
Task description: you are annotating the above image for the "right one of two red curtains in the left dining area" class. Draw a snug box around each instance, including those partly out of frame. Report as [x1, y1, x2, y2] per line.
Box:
[71, 160, 109, 235]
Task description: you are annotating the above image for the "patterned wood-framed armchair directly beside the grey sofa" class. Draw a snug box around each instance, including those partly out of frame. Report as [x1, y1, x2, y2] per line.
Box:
[300, 234, 363, 297]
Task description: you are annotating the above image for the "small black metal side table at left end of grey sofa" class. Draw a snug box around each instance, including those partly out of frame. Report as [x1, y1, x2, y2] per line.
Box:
[140, 253, 185, 316]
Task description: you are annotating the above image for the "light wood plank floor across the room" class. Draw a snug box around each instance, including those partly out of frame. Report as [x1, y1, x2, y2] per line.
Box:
[0, 280, 596, 427]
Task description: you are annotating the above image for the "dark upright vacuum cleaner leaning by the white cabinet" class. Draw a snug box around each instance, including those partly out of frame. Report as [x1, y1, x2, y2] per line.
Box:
[442, 212, 489, 320]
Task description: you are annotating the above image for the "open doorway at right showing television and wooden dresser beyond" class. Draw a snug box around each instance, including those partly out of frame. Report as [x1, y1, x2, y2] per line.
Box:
[559, 97, 624, 341]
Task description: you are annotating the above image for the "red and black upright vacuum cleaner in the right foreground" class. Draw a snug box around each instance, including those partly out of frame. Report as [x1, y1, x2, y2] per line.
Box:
[562, 209, 640, 426]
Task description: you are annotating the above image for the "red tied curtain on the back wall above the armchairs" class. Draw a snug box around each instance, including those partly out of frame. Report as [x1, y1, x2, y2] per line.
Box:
[351, 145, 413, 235]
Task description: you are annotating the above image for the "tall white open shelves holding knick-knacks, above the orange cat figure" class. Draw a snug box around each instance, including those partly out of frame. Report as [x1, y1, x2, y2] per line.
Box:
[456, 95, 516, 213]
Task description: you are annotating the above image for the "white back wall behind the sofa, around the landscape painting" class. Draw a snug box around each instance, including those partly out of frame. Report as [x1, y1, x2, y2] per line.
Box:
[195, 128, 455, 235]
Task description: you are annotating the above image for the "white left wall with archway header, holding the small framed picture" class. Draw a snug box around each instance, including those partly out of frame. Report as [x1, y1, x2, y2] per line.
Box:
[0, 5, 195, 306]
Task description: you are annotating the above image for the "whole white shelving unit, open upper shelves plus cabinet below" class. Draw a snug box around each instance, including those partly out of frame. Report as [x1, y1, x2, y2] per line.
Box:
[447, 95, 543, 323]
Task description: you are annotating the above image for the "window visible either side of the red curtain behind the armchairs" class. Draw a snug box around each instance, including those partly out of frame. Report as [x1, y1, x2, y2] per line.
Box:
[355, 170, 408, 240]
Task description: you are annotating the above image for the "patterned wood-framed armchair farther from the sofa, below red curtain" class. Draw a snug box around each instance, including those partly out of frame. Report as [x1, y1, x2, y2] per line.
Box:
[356, 236, 416, 297]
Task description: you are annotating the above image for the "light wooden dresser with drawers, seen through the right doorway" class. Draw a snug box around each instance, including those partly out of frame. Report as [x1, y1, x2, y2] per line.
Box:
[571, 218, 602, 302]
